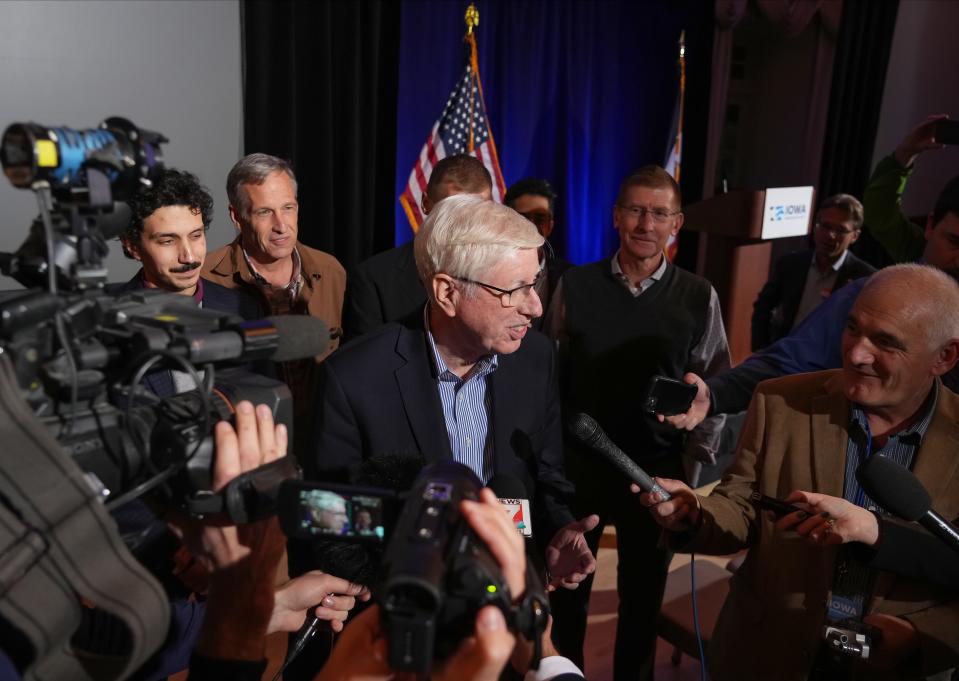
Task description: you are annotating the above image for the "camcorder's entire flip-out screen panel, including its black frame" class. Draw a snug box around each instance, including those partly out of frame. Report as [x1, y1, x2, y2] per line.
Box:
[277, 481, 398, 544]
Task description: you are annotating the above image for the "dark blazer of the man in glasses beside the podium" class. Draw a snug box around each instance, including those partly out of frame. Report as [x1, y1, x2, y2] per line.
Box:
[752, 251, 876, 352]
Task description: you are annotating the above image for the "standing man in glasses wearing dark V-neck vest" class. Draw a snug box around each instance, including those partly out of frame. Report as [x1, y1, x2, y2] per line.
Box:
[545, 166, 729, 681]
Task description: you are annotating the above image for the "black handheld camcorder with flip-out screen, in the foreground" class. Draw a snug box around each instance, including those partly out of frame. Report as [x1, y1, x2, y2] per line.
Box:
[279, 462, 549, 674]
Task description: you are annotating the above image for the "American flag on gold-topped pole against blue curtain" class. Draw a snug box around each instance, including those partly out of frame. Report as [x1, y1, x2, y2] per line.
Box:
[400, 5, 506, 232]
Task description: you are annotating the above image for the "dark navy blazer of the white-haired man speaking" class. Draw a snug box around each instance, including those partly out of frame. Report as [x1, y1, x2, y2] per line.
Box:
[312, 310, 573, 546]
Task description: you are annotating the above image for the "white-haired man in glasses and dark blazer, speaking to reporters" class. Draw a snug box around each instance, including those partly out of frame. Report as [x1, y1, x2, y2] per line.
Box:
[308, 195, 598, 588]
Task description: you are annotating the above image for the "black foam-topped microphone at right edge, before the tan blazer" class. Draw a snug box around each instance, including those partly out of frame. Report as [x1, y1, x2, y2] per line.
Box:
[856, 455, 959, 551]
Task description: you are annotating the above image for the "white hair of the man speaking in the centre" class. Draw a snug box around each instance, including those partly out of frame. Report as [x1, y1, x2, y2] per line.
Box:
[413, 194, 545, 299]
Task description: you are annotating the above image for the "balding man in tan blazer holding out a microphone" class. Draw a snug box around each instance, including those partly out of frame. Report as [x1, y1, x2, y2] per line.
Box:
[634, 264, 959, 681]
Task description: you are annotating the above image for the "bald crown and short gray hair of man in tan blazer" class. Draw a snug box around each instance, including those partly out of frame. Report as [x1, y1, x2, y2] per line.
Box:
[859, 263, 959, 349]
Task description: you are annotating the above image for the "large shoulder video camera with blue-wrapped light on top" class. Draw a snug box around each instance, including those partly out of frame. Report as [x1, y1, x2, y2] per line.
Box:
[0, 117, 316, 522]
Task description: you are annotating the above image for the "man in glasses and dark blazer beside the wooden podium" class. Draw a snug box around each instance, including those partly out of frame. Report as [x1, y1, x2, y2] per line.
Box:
[752, 194, 876, 352]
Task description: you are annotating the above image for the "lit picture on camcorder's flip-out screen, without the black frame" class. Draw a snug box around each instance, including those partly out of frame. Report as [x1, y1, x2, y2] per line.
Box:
[297, 489, 386, 542]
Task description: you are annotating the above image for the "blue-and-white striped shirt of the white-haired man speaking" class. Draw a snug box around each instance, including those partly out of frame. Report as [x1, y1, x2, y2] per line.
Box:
[426, 325, 499, 483]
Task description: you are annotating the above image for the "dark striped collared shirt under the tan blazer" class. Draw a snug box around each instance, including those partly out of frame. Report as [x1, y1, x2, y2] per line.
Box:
[843, 381, 939, 513]
